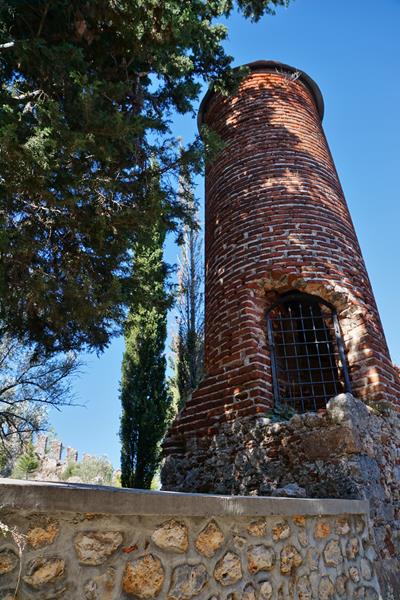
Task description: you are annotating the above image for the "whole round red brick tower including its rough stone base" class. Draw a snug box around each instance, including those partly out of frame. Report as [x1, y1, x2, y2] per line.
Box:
[162, 61, 400, 598]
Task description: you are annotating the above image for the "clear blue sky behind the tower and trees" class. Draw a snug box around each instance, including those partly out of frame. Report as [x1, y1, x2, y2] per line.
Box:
[51, 0, 400, 466]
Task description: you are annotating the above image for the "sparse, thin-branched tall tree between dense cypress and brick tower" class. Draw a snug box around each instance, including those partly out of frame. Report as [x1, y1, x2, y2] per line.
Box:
[171, 171, 204, 409]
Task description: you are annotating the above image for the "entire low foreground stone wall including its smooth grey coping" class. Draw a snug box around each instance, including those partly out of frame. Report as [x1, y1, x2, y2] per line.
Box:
[0, 480, 386, 600]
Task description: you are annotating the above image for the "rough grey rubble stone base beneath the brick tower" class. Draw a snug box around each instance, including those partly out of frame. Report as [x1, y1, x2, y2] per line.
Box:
[163, 394, 400, 598]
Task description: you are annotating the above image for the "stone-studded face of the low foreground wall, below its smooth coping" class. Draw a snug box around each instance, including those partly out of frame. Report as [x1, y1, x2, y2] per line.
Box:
[0, 489, 386, 600]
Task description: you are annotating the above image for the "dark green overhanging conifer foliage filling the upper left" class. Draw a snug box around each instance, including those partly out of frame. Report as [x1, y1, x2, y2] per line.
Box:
[0, 0, 286, 352]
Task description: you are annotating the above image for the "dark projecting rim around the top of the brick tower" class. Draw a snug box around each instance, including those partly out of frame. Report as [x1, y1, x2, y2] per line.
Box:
[197, 60, 324, 131]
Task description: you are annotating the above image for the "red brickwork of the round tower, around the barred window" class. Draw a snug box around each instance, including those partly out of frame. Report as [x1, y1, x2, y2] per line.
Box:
[166, 63, 400, 452]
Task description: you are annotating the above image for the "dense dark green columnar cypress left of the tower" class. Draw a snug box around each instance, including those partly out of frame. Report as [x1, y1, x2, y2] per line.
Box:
[120, 186, 171, 489]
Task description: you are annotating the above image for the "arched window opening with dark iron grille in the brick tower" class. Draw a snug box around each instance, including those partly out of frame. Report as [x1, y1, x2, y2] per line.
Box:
[267, 292, 351, 412]
